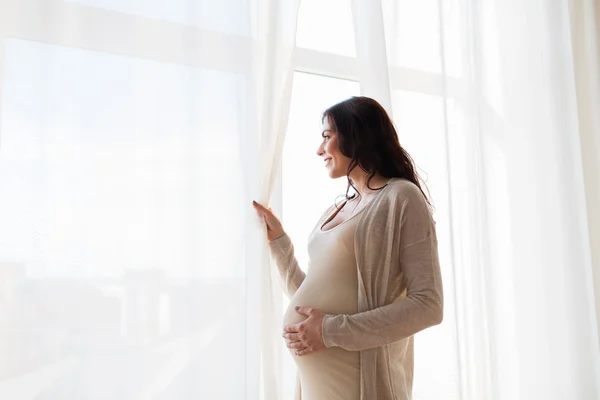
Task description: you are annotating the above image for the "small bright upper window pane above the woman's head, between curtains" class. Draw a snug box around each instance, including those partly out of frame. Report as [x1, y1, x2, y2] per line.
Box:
[296, 0, 356, 57]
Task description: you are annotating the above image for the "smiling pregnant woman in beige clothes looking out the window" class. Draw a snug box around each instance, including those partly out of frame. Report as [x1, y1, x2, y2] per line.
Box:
[253, 97, 443, 400]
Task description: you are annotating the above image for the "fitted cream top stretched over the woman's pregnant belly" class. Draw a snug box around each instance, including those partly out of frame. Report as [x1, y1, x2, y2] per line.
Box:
[283, 206, 362, 400]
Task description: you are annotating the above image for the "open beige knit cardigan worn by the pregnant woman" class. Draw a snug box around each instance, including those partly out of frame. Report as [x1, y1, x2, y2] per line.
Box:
[269, 178, 443, 400]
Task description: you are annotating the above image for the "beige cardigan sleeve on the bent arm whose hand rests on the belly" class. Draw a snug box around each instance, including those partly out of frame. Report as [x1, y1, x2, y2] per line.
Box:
[322, 186, 443, 351]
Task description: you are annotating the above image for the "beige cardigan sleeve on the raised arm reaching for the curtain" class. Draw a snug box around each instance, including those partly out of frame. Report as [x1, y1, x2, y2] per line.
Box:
[269, 233, 306, 298]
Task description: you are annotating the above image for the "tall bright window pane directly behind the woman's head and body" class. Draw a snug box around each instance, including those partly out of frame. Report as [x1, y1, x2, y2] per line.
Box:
[283, 82, 459, 400]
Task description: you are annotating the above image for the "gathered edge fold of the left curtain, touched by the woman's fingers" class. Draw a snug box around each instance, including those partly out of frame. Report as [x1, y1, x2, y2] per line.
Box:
[249, 0, 300, 400]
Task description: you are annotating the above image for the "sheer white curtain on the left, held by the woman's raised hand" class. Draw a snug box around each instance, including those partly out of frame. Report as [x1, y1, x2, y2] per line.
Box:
[0, 0, 298, 400]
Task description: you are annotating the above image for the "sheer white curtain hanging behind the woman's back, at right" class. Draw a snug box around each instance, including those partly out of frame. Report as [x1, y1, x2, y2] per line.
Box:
[376, 0, 600, 400]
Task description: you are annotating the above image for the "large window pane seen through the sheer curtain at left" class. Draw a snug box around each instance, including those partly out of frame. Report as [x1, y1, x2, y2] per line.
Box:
[0, 17, 248, 399]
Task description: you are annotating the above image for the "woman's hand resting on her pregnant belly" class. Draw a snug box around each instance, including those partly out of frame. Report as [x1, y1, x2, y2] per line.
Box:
[283, 307, 327, 356]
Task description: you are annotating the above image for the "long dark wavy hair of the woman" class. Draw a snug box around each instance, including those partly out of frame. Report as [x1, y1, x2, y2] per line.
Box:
[321, 96, 433, 208]
